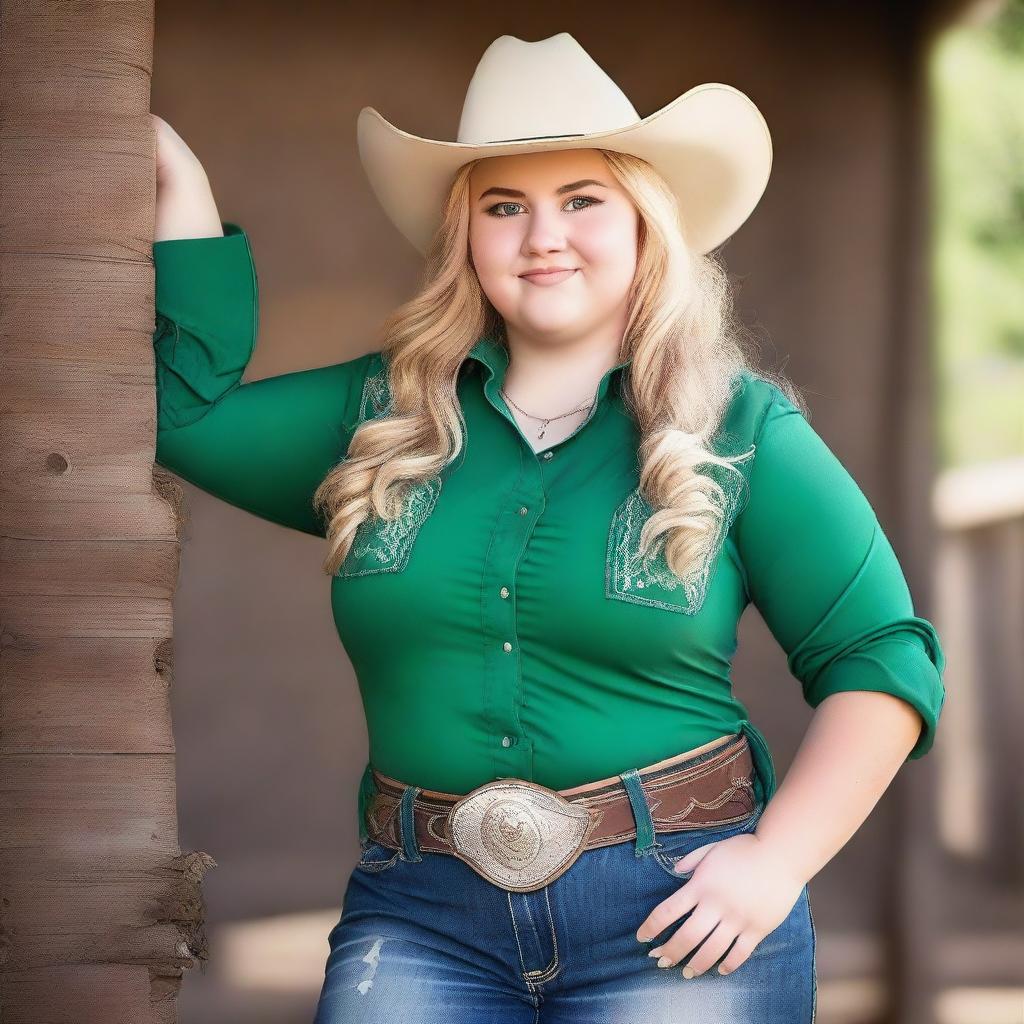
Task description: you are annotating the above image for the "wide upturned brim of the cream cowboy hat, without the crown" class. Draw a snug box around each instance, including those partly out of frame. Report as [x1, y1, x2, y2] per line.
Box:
[356, 82, 772, 254]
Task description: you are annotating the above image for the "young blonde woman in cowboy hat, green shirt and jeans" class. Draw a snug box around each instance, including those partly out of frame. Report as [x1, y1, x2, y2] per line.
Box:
[154, 33, 944, 1024]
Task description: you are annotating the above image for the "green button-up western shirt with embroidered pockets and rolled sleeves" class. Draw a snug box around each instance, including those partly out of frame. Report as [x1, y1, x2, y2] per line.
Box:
[153, 223, 945, 838]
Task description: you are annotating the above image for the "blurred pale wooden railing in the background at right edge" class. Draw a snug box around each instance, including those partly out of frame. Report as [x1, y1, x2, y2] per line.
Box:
[933, 458, 1024, 887]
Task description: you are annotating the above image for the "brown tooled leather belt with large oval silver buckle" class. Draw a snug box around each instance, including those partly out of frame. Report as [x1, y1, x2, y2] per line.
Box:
[367, 732, 757, 892]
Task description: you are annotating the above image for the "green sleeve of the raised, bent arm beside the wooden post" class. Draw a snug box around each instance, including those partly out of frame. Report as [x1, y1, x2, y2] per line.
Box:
[153, 222, 370, 537]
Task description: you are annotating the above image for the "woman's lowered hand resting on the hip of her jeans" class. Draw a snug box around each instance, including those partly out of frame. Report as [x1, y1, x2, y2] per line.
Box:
[637, 833, 806, 978]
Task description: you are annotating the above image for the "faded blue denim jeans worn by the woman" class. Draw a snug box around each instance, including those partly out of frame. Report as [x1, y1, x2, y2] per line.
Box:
[314, 751, 817, 1024]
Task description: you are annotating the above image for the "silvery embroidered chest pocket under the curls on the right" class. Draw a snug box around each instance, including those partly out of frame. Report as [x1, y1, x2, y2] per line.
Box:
[604, 456, 753, 615]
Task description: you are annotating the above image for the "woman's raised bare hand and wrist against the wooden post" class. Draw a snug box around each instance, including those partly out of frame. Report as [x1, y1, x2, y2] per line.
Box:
[150, 113, 224, 242]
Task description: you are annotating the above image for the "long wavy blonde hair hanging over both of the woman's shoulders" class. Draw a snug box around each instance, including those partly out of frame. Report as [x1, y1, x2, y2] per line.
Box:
[313, 150, 806, 580]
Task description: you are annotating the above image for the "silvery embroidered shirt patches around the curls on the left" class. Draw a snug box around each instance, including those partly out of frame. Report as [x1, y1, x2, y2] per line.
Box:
[335, 354, 441, 578]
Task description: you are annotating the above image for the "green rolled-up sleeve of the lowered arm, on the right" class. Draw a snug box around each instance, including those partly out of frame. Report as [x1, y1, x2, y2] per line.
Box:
[736, 387, 945, 760]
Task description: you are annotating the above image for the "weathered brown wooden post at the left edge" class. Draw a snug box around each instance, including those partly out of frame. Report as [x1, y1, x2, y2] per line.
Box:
[0, 0, 213, 1024]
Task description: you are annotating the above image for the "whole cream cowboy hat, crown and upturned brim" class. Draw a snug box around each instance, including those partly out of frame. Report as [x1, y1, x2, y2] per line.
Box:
[356, 32, 772, 254]
